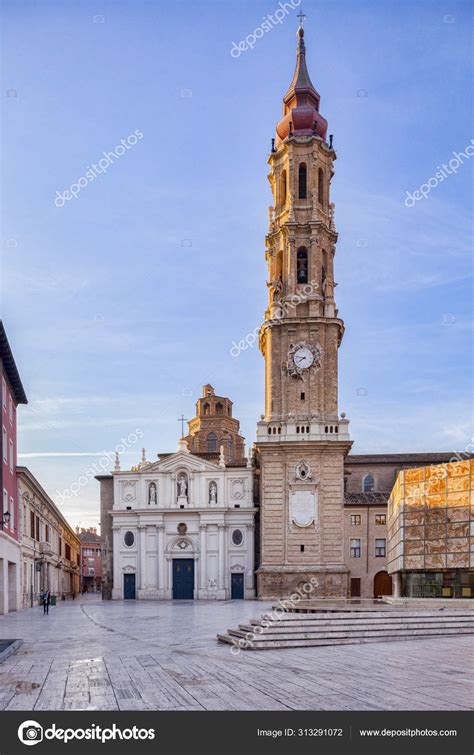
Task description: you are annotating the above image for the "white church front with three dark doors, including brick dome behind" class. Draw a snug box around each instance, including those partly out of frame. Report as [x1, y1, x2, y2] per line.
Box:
[98, 386, 256, 600]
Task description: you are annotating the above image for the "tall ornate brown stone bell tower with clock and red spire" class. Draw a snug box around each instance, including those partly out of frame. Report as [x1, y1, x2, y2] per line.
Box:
[256, 28, 351, 598]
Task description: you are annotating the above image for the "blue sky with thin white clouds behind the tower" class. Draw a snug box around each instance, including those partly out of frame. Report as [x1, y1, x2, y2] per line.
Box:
[0, 0, 474, 527]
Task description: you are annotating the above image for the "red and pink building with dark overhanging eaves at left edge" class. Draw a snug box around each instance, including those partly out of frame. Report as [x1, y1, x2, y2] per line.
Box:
[0, 321, 28, 614]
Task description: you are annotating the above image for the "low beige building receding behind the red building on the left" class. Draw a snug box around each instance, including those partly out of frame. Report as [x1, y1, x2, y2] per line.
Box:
[17, 467, 81, 608]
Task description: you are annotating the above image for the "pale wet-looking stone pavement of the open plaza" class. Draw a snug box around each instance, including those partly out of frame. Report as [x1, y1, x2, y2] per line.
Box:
[0, 595, 474, 710]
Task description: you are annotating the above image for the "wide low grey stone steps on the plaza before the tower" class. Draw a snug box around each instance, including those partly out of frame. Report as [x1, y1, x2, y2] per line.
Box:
[217, 607, 474, 650]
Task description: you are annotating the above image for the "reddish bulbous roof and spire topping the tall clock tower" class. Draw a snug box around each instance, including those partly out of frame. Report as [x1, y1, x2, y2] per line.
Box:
[276, 28, 328, 146]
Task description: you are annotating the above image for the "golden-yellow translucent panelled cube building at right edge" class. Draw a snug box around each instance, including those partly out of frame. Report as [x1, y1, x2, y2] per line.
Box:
[387, 459, 474, 598]
